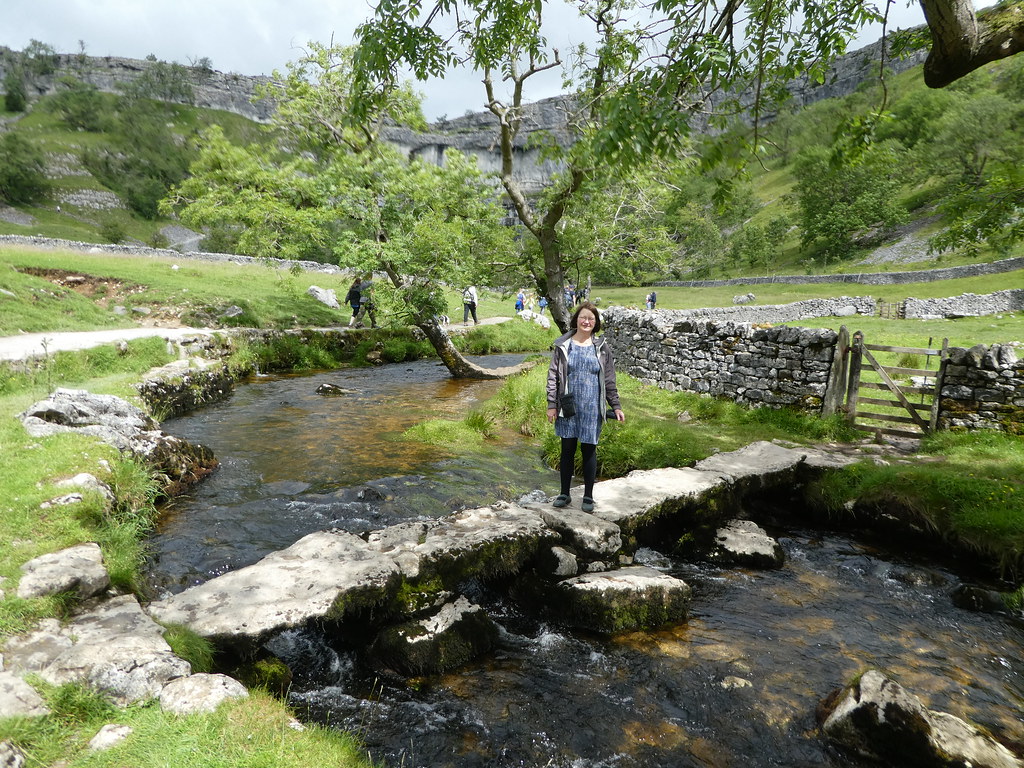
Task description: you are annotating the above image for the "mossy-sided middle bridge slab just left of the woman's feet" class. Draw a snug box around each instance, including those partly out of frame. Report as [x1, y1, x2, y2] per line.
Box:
[368, 503, 559, 579]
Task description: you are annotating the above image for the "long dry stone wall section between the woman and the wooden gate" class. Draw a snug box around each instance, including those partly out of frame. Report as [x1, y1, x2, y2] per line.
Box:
[601, 307, 838, 411]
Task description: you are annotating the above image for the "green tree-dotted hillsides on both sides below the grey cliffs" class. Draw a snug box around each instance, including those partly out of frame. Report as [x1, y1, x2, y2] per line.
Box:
[0, 51, 1024, 281]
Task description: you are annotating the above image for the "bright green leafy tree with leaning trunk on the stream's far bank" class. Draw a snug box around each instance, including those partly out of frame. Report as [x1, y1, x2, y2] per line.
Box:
[164, 44, 515, 378]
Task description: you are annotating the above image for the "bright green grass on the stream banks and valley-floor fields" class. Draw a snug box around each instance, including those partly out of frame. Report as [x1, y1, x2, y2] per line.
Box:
[0, 241, 1024, 768]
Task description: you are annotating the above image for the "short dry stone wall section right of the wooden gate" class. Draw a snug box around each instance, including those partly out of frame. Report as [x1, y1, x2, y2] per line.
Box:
[937, 344, 1024, 435]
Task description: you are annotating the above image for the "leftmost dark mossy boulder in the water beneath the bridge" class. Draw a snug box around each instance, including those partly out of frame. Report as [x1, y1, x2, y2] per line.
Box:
[370, 595, 498, 675]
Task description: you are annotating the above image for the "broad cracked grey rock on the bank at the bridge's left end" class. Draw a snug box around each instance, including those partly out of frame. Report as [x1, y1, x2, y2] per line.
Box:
[4, 595, 191, 707]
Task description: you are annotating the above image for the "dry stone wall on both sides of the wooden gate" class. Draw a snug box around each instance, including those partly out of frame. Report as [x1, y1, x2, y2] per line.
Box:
[601, 307, 1024, 434]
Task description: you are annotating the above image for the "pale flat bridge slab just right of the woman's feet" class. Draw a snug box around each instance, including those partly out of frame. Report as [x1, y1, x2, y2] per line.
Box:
[572, 467, 726, 532]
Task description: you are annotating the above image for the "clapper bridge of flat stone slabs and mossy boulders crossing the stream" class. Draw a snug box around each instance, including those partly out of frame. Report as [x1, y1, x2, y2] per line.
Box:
[147, 442, 864, 673]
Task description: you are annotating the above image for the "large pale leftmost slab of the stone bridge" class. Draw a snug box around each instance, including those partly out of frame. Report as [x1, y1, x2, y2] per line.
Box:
[148, 531, 398, 644]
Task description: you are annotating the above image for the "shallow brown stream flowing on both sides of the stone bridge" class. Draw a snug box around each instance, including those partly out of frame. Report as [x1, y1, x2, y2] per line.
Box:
[153, 361, 1024, 768]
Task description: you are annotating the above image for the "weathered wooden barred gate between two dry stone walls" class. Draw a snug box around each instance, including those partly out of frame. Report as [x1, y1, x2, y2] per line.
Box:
[844, 329, 949, 437]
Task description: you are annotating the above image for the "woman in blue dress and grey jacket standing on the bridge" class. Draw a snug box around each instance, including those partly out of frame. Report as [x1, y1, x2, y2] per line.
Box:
[548, 301, 626, 512]
